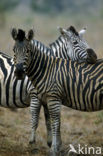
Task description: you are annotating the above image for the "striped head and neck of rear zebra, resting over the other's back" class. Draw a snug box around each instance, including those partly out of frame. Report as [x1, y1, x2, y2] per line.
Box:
[32, 26, 93, 63]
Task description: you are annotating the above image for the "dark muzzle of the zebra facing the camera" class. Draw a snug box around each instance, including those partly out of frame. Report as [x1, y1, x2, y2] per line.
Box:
[14, 63, 25, 80]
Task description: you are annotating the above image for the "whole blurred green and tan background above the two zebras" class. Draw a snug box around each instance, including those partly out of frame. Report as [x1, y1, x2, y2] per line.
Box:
[0, 0, 103, 57]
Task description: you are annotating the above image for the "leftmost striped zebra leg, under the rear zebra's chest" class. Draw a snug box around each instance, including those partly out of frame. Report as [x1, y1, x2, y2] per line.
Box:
[29, 96, 41, 144]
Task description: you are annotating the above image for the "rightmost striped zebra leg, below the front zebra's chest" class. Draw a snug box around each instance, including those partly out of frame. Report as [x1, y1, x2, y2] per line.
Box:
[48, 97, 62, 156]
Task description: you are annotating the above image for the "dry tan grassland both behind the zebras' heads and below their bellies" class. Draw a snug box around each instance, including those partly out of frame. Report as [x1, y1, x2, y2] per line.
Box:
[0, 11, 103, 156]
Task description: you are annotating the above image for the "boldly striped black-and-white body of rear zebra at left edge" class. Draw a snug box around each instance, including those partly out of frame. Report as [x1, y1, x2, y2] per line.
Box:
[0, 52, 30, 108]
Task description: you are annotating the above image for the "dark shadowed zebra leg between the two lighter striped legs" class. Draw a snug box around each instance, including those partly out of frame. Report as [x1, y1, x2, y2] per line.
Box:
[43, 104, 52, 147]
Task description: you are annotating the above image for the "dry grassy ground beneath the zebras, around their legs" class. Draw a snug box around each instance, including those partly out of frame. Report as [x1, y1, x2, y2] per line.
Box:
[0, 107, 103, 156]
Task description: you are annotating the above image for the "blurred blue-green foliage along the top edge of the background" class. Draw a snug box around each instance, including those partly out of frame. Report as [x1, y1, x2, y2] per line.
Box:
[31, 0, 103, 13]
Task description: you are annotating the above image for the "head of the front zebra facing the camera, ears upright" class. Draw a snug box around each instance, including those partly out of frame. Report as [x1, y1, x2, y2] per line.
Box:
[11, 28, 34, 79]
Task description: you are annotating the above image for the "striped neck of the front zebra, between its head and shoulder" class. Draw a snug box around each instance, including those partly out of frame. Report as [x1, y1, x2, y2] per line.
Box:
[26, 44, 58, 89]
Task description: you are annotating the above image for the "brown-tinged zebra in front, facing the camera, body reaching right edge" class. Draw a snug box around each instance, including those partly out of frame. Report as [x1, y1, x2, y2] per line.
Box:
[11, 29, 103, 156]
